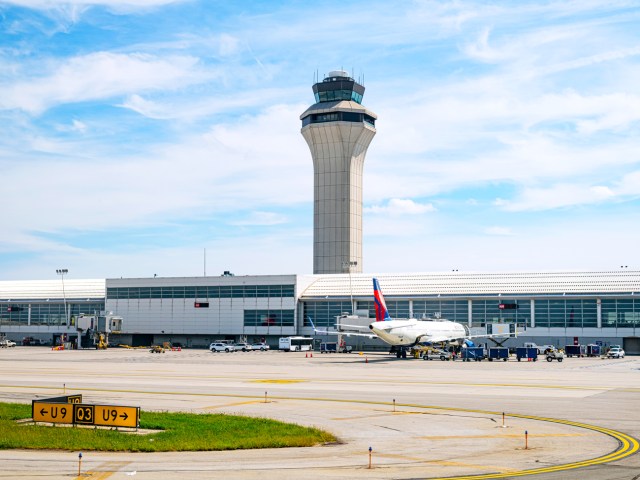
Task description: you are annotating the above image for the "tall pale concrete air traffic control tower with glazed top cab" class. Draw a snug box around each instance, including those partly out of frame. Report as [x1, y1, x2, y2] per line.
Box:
[300, 70, 378, 274]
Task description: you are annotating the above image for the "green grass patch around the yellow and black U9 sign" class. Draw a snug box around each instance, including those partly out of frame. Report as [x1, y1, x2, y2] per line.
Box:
[0, 403, 336, 452]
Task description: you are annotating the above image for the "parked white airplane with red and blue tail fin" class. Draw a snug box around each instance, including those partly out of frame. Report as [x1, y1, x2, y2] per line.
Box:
[310, 278, 505, 357]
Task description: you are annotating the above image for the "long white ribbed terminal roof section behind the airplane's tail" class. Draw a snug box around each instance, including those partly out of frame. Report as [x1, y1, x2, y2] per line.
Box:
[300, 270, 640, 299]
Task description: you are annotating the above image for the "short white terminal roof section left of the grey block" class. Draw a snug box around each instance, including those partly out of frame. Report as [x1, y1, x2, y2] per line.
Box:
[0, 278, 106, 301]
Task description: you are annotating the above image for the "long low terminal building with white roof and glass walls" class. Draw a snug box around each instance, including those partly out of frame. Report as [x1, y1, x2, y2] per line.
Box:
[0, 270, 640, 354]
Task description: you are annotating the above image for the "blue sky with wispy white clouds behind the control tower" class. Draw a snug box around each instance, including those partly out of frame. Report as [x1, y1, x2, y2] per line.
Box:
[0, 0, 640, 280]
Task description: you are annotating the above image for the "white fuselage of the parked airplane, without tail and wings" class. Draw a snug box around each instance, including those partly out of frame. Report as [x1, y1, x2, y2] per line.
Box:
[369, 319, 468, 346]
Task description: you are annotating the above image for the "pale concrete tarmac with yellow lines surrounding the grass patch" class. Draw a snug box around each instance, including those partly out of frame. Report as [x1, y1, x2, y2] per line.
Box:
[0, 347, 640, 480]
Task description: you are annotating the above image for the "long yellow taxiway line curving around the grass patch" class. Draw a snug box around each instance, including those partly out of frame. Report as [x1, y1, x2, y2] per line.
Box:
[0, 385, 640, 480]
